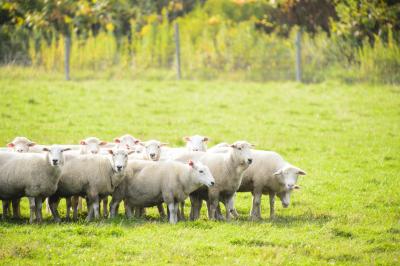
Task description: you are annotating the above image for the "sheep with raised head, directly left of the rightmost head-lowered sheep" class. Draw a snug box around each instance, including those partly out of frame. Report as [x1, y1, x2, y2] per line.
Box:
[176, 141, 253, 220]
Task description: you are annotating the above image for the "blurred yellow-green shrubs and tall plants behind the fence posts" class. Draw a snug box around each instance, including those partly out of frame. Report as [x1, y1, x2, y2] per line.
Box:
[0, 0, 400, 83]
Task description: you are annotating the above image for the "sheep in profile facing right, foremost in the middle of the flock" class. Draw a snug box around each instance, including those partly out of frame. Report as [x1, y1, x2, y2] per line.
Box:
[110, 160, 215, 224]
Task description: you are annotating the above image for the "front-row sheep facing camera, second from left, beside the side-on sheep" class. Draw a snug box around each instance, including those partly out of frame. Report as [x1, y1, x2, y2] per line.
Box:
[49, 149, 128, 222]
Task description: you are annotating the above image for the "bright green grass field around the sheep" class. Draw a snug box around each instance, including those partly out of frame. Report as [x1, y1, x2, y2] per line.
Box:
[0, 69, 400, 265]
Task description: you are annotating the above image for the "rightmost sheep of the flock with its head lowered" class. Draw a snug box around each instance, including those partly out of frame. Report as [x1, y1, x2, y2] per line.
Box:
[212, 150, 306, 220]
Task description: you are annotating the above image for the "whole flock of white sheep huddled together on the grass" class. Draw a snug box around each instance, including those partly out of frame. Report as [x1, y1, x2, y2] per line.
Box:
[0, 135, 306, 223]
